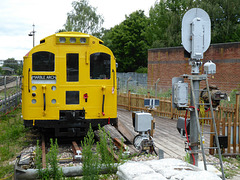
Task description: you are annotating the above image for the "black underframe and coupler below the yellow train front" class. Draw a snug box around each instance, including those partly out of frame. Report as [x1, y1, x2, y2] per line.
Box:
[24, 110, 118, 137]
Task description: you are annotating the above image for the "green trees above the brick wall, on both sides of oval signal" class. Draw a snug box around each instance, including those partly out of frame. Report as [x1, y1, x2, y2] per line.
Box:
[147, 0, 240, 48]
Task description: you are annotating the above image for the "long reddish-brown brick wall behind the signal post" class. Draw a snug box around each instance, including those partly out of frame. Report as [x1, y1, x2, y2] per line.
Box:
[148, 42, 240, 92]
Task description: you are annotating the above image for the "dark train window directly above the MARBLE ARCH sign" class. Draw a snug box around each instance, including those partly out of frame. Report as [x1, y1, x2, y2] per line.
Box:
[32, 51, 55, 71]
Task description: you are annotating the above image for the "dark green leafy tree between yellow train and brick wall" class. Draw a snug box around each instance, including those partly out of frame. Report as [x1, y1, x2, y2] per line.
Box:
[103, 10, 148, 72]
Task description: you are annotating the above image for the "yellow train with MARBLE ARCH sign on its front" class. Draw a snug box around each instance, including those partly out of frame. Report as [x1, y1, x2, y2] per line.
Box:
[22, 32, 117, 136]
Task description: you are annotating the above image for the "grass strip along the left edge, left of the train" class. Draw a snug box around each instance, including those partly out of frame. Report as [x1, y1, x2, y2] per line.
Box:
[0, 107, 27, 179]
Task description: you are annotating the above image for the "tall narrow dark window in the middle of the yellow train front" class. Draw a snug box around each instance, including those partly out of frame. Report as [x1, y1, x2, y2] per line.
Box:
[67, 54, 79, 82]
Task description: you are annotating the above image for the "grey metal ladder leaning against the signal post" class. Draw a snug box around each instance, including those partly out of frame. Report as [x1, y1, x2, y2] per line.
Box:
[189, 75, 225, 180]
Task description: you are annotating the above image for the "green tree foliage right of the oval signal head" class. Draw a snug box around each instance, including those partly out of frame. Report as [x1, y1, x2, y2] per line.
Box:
[198, 0, 240, 43]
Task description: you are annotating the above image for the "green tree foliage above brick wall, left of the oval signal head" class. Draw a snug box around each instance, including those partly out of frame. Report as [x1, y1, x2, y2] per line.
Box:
[147, 0, 195, 48]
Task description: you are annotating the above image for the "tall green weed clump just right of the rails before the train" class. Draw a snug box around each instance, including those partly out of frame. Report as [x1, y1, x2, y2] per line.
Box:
[82, 125, 127, 180]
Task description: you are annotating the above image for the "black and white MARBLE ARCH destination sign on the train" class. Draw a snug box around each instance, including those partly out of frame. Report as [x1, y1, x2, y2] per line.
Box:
[32, 75, 57, 84]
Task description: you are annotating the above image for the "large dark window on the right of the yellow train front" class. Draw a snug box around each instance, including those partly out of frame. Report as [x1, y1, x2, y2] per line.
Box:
[90, 52, 111, 79]
